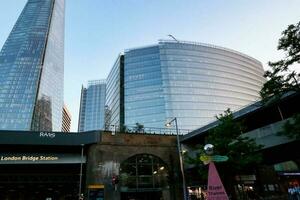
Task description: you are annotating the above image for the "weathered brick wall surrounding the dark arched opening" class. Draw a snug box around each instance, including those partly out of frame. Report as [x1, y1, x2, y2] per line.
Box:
[86, 132, 181, 200]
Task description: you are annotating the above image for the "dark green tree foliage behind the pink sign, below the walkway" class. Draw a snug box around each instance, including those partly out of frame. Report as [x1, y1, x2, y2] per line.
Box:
[206, 109, 262, 172]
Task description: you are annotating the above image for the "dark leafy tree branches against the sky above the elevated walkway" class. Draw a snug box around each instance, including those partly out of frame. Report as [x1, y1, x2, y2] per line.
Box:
[260, 22, 300, 103]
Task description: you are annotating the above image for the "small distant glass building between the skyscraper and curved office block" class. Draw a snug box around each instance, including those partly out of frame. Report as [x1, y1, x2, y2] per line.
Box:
[78, 80, 106, 132]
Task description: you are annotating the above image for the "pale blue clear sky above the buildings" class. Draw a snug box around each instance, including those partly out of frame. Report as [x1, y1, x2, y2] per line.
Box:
[0, 0, 300, 131]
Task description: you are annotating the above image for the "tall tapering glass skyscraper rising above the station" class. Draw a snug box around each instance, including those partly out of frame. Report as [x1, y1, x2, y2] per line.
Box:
[0, 0, 64, 131]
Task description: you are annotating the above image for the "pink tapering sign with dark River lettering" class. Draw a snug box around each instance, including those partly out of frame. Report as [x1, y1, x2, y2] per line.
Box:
[207, 162, 228, 200]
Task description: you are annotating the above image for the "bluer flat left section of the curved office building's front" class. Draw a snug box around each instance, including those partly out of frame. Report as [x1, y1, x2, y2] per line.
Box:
[124, 45, 167, 128]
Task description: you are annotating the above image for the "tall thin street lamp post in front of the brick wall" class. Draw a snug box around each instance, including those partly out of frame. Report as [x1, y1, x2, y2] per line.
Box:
[166, 117, 188, 200]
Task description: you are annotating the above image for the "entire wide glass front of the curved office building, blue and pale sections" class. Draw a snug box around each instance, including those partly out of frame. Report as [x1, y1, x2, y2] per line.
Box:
[124, 41, 264, 130]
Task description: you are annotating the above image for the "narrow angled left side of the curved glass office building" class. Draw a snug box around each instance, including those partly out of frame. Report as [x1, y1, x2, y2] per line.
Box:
[105, 55, 124, 130]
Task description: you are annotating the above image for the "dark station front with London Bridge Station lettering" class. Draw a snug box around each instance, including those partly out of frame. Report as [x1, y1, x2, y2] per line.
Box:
[0, 131, 99, 200]
